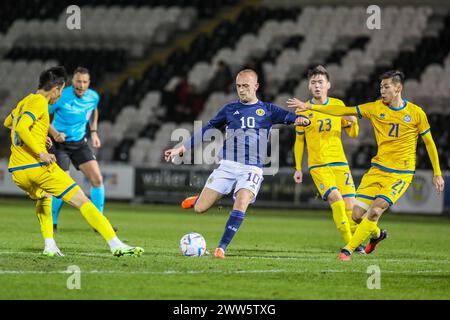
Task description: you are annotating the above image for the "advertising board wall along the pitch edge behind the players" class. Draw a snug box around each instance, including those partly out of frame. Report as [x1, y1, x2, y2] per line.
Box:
[0, 160, 450, 214]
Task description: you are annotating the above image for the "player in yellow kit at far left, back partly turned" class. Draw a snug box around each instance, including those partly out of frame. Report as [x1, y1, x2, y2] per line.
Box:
[4, 67, 144, 257]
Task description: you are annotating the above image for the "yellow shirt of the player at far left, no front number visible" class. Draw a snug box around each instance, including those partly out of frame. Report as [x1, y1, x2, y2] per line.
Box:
[5, 94, 50, 169]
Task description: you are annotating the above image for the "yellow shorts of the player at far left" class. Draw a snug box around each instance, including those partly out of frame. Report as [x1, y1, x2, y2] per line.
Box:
[10, 163, 80, 202]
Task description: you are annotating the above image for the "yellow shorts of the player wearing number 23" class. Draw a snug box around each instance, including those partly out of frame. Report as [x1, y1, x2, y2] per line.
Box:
[309, 165, 355, 201]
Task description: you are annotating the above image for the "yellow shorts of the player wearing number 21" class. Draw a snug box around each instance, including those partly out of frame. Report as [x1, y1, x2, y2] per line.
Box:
[356, 166, 414, 210]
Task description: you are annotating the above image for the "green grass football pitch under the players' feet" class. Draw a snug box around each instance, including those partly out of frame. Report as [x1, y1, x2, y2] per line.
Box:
[0, 199, 450, 299]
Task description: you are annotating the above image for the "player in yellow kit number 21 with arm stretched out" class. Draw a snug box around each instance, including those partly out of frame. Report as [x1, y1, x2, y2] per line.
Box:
[287, 70, 444, 261]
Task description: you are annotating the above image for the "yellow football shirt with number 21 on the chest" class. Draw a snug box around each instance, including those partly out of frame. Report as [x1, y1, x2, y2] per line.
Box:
[356, 100, 430, 174]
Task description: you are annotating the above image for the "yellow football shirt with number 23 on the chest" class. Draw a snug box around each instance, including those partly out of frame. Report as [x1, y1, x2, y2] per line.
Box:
[295, 97, 358, 169]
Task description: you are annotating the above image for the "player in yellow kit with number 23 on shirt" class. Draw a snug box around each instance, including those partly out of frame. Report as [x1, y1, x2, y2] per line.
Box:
[294, 65, 365, 253]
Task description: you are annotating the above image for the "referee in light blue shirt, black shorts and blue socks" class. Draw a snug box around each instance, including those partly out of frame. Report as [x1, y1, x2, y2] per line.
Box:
[49, 67, 108, 232]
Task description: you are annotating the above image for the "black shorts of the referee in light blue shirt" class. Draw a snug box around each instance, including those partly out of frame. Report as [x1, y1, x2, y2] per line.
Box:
[50, 138, 97, 171]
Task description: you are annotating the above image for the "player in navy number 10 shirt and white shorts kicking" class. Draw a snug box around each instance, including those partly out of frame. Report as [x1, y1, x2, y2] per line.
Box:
[164, 69, 311, 259]
